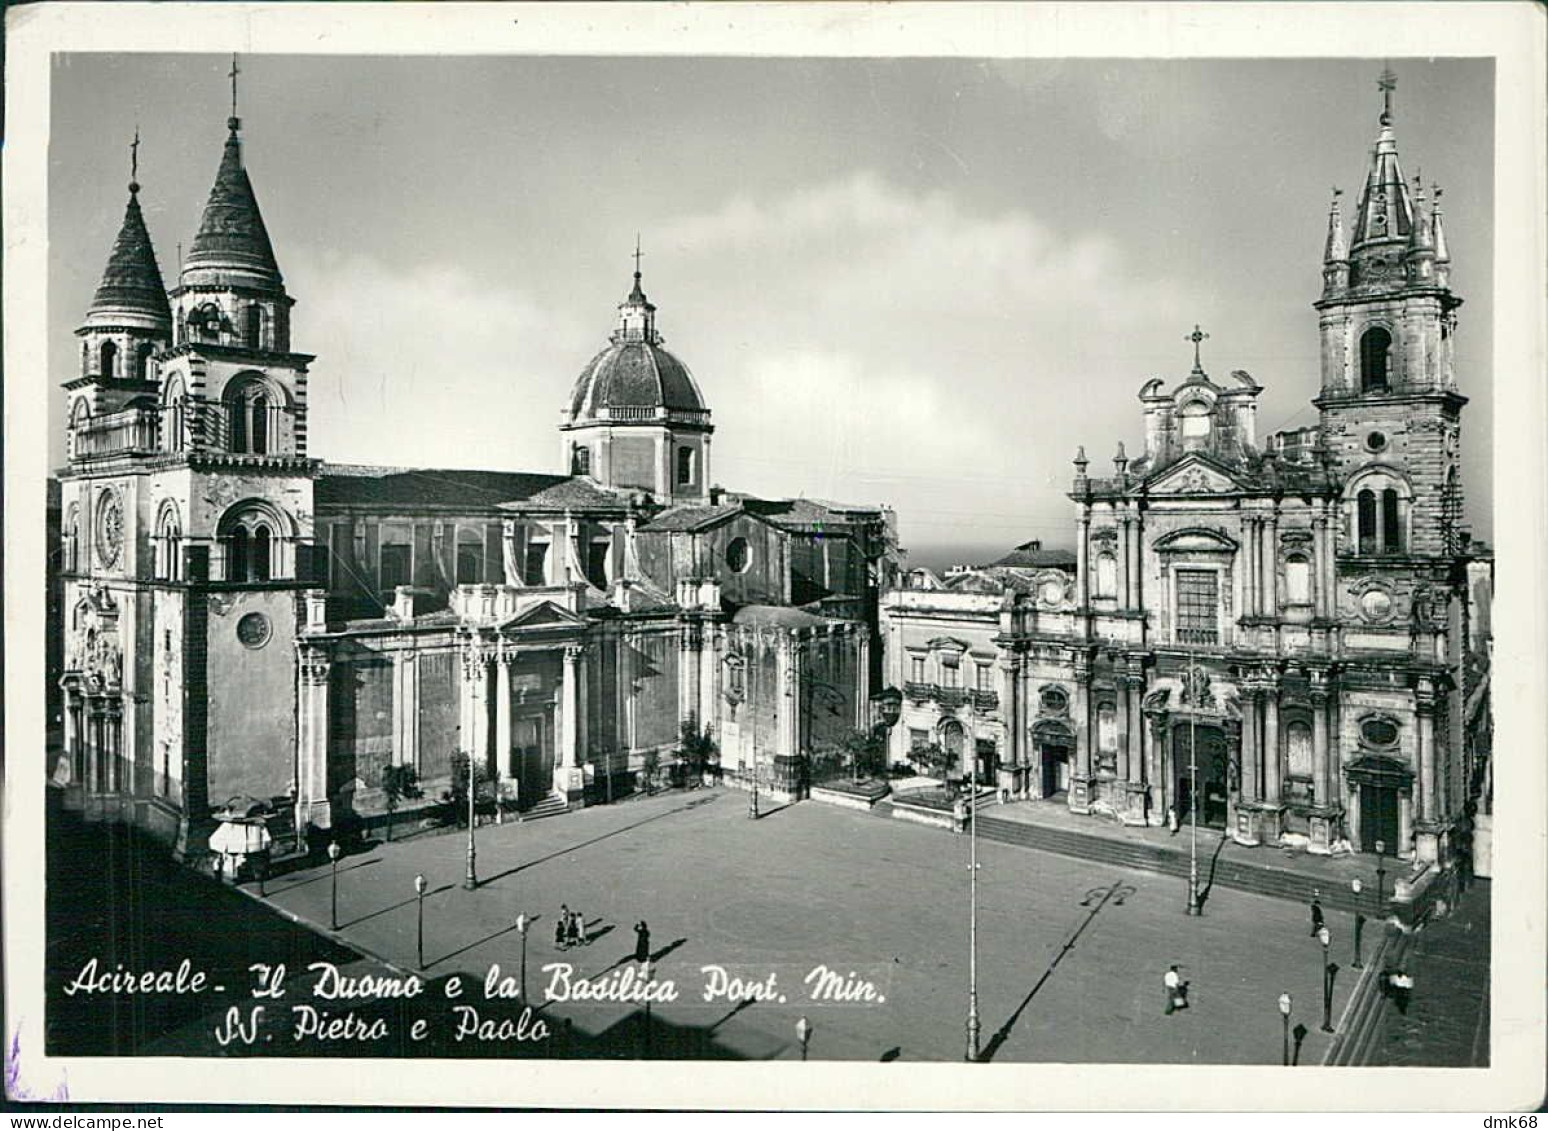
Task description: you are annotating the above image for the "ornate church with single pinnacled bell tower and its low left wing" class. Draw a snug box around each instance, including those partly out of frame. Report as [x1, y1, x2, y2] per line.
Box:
[882, 76, 1488, 866]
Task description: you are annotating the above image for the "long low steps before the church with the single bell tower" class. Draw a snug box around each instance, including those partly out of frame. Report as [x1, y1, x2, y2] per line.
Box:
[978, 817, 1373, 914]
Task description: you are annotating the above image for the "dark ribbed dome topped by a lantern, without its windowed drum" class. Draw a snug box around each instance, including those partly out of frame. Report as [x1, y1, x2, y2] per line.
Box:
[568, 272, 709, 424]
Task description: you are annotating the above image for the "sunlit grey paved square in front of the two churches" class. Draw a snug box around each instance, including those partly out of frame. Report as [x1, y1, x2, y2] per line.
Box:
[250, 789, 1373, 1064]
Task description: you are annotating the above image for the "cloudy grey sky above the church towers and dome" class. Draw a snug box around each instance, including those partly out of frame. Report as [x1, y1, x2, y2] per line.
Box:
[48, 54, 1494, 563]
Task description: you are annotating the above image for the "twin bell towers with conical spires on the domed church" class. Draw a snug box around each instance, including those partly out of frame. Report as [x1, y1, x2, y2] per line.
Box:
[62, 60, 316, 857]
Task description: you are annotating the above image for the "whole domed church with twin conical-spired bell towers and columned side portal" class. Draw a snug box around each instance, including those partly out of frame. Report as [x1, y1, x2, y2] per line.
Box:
[54, 92, 896, 859]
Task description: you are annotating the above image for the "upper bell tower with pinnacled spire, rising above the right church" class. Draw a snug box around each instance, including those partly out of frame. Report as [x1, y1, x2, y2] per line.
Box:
[1314, 71, 1468, 557]
